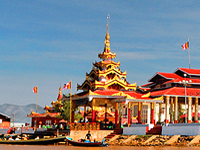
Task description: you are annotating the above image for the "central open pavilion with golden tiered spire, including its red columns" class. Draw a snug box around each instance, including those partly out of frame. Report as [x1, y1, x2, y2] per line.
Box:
[62, 22, 163, 130]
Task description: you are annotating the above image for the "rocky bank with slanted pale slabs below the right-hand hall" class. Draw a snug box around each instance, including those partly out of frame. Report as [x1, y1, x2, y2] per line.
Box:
[107, 135, 200, 147]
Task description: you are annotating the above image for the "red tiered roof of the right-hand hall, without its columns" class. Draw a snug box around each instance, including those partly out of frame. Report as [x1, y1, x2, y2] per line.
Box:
[142, 68, 200, 97]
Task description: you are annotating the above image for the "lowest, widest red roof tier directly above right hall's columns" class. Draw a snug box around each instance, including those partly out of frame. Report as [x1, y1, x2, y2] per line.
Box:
[151, 87, 200, 97]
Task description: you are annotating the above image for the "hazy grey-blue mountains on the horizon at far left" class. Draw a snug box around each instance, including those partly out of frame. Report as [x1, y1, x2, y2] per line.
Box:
[0, 104, 45, 123]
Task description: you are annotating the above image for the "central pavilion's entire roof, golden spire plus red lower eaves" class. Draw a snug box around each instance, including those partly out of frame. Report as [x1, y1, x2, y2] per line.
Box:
[63, 22, 163, 107]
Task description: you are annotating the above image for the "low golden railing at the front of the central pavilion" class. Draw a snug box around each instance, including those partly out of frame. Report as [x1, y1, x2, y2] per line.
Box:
[70, 122, 100, 130]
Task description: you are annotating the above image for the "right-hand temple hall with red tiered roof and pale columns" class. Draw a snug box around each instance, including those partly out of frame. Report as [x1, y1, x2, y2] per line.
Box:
[142, 68, 200, 123]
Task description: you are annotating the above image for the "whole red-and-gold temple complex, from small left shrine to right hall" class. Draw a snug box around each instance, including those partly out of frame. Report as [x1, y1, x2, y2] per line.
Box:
[29, 20, 200, 135]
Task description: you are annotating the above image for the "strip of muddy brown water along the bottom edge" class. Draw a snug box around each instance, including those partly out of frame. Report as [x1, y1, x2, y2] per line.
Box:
[0, 145, 200, 150]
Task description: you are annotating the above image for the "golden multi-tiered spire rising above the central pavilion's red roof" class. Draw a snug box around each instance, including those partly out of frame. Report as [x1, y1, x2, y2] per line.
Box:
[77, 24, 136, 92]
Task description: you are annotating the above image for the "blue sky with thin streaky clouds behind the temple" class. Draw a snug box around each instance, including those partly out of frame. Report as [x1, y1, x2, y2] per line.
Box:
[0, 0, 200, 106]
